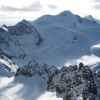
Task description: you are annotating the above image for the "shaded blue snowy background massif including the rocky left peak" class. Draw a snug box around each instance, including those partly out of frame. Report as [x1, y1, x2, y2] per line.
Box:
[0, 11, 100, 67]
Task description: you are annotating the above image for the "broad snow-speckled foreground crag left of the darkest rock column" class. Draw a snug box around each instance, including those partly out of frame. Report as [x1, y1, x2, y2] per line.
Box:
[47, 63, 86, 100]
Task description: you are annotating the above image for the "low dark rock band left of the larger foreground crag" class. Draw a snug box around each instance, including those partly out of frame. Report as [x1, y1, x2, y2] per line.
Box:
[15, 60, 58, 81]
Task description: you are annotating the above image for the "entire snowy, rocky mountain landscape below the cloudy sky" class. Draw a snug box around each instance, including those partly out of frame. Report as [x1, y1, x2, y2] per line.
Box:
[0, 11, 100, 100]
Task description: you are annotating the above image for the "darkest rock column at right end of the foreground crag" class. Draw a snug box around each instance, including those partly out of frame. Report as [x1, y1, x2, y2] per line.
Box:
[83, 66, 97, 100]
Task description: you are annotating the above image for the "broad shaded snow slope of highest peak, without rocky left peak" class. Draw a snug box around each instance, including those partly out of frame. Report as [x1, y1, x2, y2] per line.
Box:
[30, 11, 100, 66]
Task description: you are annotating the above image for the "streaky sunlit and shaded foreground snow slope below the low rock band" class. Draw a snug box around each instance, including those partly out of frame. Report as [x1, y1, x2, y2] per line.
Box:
[0, 76, 62, 100]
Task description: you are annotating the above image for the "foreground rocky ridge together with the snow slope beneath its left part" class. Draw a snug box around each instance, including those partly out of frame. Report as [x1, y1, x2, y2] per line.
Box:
[0, 60, 100, 100]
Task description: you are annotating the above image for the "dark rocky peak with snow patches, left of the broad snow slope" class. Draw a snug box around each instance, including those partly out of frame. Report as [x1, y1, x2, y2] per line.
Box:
[0, 20, 42, 59]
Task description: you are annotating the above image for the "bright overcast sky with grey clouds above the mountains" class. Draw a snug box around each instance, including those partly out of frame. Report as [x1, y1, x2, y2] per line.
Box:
[0, 0, 100, 25]
